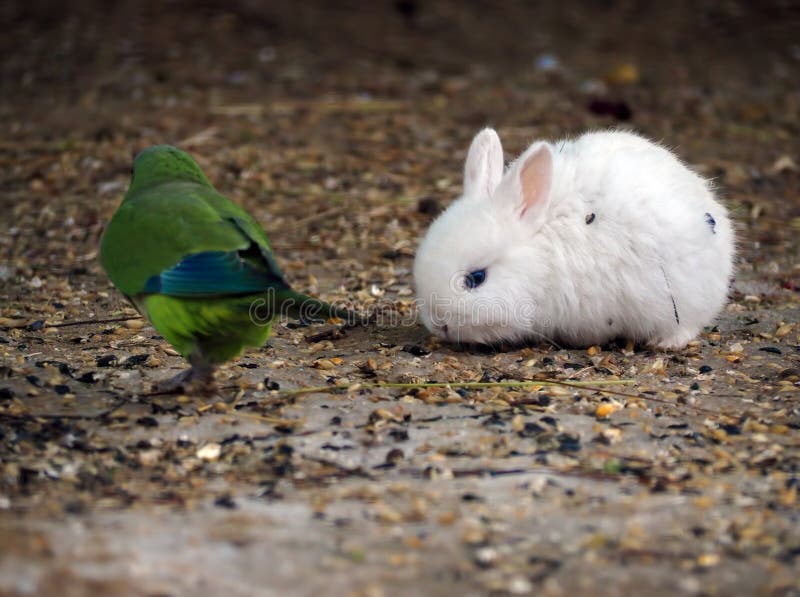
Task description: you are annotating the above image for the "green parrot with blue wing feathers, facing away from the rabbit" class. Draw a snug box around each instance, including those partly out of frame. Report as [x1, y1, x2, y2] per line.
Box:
[100, 145, 354, 390]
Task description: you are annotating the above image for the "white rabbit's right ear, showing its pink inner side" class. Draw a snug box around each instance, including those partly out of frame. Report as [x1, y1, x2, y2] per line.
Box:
[498, 143, 553, 229]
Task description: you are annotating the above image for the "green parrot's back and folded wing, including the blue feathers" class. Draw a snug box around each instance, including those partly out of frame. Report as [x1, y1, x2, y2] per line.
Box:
[100, 182, 288, 298]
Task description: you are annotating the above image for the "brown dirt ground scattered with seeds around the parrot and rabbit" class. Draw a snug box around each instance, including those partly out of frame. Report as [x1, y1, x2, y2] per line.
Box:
[0, 0, 800, 597]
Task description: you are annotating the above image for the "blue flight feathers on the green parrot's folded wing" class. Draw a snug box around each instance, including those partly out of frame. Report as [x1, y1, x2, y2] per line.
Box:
[144, 251, 286, 297]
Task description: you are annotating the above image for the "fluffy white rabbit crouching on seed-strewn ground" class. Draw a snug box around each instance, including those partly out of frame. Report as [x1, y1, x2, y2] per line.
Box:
[414, 128, 734, 349]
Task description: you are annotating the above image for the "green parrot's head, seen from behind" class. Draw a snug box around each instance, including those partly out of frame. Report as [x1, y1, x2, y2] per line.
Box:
[127, 145, 213, 197]
